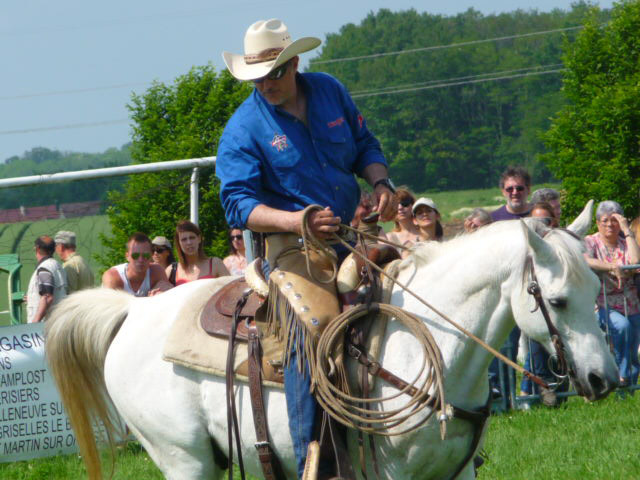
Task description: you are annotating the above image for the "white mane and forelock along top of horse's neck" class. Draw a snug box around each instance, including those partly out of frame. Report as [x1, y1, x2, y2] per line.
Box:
[400, 218, 591, 282]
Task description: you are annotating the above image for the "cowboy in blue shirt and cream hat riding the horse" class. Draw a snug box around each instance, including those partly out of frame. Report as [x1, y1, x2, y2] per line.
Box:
[216, 19, 395, 476]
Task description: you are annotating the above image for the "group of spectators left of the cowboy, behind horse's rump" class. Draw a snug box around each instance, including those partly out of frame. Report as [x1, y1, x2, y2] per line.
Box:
[23, 220, 247, 316]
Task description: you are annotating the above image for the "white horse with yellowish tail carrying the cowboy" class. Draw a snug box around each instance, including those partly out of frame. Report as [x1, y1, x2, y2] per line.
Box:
[46, 205, 618, 480]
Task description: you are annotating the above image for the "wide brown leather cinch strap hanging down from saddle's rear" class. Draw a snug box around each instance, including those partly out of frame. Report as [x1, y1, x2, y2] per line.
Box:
[248, 325, 285, 480]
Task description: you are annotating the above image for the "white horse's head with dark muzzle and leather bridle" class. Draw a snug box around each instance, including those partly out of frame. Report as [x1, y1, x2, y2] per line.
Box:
[512, 201, 618, 400]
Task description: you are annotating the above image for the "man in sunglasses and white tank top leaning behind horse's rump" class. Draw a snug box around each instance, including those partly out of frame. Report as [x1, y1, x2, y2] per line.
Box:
[102, 232, 173, 297]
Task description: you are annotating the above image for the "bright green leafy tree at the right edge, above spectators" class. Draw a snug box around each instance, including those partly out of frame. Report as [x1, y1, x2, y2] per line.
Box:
[544, 1, 640, 217]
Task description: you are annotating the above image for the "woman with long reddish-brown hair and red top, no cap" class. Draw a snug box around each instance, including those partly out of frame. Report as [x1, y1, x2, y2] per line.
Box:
[167, 220, 229, 286]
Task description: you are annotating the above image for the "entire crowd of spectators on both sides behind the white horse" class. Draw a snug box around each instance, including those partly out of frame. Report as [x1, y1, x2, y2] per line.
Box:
[24, 167, 640, 404]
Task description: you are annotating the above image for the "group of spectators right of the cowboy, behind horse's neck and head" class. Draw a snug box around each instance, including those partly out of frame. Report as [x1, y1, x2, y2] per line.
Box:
[376, 167, 640, 399]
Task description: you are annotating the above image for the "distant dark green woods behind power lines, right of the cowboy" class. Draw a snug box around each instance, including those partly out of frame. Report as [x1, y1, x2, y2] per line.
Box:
[309, 2, 609, 192]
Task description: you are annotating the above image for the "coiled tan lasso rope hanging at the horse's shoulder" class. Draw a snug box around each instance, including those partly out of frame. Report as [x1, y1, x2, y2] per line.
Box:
[316, 304, 448, 438]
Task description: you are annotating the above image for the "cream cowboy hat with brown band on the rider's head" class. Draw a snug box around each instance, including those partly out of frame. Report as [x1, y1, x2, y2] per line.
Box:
[222, 18, 321, 80]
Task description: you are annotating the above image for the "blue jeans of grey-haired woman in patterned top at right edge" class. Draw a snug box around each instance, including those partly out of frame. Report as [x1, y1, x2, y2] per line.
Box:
[598, 308, 640, 385]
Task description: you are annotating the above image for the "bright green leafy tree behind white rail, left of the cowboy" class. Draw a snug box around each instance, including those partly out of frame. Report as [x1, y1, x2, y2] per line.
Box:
[98, 65, 251, 267]
